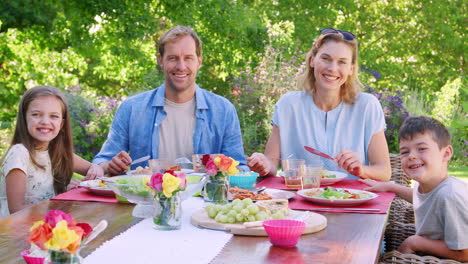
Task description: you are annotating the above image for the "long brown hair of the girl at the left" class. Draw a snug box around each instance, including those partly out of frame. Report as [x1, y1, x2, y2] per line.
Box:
[10, 85, 73, 194]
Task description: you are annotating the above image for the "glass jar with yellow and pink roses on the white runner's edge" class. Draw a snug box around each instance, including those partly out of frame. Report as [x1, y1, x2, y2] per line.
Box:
[147, 170, 186, 230]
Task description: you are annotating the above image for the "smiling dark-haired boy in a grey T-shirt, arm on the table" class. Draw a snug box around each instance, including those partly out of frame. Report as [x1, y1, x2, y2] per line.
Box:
[362, 116, 468, 262]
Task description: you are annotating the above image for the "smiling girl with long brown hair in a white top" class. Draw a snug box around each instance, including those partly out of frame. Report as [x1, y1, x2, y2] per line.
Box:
[0, 86, 103, 216]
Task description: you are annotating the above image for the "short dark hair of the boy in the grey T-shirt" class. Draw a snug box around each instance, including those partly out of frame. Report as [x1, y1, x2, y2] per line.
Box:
[398, 116, 451, 149]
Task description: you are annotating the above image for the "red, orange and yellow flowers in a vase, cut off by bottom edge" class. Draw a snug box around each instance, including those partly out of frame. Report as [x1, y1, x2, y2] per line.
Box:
[24, 210, 93, 264]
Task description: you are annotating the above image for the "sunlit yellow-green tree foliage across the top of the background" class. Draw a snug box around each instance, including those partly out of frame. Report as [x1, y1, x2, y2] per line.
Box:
[0, 0, 467, 165]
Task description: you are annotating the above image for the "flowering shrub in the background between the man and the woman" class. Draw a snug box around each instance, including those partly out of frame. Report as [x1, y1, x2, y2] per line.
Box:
[230, 30, 305, 154]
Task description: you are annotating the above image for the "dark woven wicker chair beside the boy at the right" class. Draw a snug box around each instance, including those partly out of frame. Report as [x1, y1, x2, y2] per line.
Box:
[380, 154, 460, 264]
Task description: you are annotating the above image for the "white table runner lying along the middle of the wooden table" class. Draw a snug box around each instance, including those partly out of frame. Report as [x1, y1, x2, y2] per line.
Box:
[84, 197, 232, 264]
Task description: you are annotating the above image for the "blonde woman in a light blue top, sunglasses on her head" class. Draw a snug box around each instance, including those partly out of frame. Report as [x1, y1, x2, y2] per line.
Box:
[247, 28, 391, 181]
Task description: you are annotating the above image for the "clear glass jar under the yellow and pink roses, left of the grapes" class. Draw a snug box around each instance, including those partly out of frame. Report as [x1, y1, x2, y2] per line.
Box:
[153, 193, 182, 230]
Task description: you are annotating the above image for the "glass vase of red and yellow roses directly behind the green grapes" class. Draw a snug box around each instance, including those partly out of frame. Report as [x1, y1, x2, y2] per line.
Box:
[202, 154, 239, 204]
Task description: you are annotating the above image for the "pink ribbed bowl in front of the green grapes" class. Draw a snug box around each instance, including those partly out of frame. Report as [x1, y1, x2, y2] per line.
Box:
[263, 219, 306, 247]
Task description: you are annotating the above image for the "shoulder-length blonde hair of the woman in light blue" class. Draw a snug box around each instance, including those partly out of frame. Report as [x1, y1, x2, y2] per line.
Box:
[298, 32, 364, 104]
